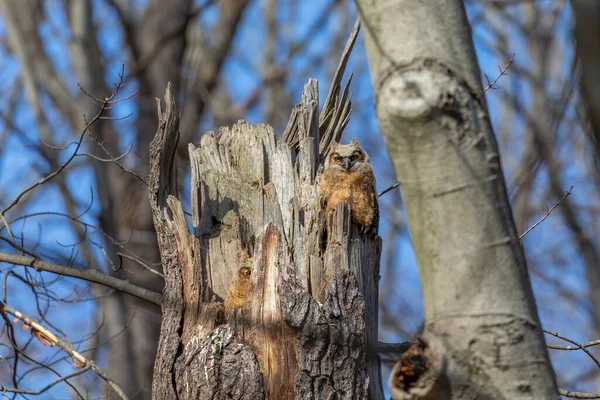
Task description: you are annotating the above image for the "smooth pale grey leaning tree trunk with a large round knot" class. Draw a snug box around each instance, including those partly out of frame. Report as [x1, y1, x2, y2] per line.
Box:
[357, 0, 558, 399]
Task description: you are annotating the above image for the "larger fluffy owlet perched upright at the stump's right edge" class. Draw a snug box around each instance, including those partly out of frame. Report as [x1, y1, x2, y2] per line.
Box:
[319, 139, 379, 234]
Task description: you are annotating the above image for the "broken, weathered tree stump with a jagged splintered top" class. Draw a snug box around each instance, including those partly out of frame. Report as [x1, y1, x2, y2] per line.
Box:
[150, 23, 383, 400]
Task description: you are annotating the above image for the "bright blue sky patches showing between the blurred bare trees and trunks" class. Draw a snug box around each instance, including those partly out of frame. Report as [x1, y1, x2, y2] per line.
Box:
[0, 0, 598, 398]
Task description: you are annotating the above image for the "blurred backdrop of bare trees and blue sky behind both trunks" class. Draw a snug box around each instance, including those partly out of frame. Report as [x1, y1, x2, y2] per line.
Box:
[0, 0, 600, 398]
